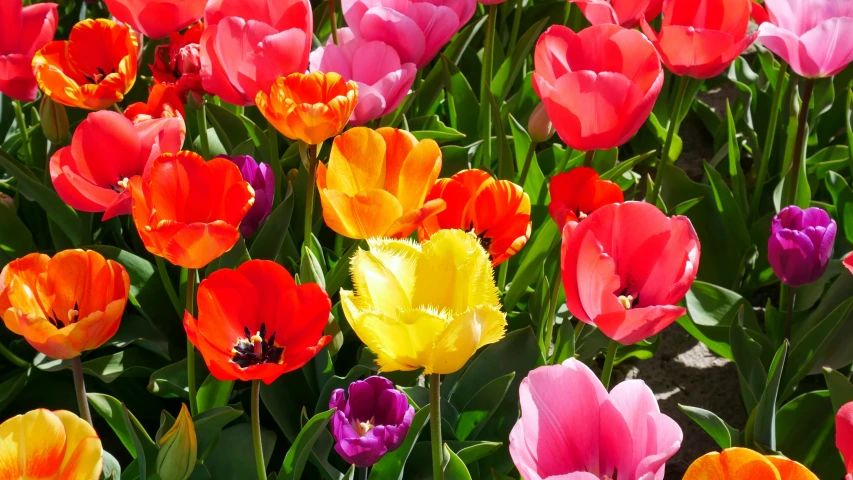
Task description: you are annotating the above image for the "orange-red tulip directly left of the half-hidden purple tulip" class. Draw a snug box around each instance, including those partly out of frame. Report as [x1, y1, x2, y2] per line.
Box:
[129, 150, 255, 268]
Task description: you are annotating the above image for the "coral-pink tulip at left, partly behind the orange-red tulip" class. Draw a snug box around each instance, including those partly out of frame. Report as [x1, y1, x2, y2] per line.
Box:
[50, 111, 186, 220]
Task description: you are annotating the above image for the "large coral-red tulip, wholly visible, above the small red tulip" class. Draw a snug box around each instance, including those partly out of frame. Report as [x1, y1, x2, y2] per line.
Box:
[533, 25, 663, 151]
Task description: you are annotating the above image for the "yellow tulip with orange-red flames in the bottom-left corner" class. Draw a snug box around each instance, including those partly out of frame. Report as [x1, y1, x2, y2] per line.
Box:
[0, 408, 104, 480]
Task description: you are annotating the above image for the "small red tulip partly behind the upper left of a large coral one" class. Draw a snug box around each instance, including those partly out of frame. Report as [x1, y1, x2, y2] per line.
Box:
[548, 167, 625, 230]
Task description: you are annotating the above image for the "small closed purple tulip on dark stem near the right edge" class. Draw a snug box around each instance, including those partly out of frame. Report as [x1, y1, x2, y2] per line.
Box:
[767, 205, 837, 287]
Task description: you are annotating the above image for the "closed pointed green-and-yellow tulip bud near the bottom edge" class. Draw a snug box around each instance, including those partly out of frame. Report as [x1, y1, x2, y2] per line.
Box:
[157, 404, 198, 480]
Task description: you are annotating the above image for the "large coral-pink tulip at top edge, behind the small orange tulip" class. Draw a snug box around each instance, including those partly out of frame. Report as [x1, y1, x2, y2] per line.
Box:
[200, 0, 313, 105]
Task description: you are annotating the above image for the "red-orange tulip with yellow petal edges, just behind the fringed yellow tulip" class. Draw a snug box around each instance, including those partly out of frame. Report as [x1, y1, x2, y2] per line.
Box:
[418, 170, 531, 266]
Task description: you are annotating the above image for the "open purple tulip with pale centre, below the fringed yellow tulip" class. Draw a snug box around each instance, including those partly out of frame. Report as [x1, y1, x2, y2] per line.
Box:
[329, 376, 415, 468]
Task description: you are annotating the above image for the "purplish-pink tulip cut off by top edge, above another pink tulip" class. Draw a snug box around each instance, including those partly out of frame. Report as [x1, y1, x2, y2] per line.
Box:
[341, 0, 477, 68]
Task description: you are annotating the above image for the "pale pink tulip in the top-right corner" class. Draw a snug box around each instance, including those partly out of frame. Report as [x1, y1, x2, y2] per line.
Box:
[758, 0, 853, 78]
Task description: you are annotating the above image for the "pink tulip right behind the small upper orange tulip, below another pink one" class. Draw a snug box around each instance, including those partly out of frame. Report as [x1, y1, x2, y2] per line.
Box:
[309, 35, 417, 126]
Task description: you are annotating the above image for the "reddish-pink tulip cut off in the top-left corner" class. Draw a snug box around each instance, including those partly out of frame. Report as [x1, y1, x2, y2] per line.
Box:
[0, 0, 59, 102]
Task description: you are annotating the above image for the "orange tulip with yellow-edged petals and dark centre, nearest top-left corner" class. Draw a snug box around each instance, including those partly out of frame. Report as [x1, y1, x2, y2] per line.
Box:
[33, 18, 139, 110]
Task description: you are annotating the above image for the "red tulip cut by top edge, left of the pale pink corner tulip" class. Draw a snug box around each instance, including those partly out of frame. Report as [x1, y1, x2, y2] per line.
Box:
[640, 0, 758, 79]
